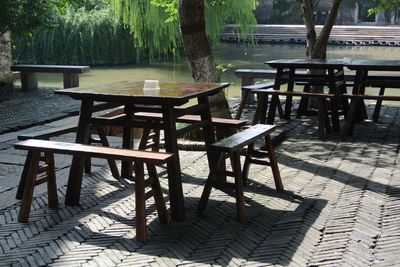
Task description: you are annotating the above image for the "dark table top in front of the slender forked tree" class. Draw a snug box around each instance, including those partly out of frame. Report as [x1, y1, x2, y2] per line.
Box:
[265, 59, 344, 69]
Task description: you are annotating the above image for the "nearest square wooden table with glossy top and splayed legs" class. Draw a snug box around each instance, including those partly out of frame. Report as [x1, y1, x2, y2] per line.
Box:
[55, 82, 229, 220]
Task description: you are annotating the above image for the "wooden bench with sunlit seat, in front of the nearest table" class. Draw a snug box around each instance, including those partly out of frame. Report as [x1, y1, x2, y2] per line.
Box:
[14, 139, 173, 242]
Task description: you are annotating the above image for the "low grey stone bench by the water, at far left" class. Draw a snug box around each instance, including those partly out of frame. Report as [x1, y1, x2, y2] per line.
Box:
[10, 64, 90, 90]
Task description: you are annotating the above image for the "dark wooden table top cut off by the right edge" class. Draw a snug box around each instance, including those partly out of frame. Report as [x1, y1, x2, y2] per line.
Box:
[345, 59, 400, 71]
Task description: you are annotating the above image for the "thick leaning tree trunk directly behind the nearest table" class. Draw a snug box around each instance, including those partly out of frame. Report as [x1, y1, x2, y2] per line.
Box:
[178, 0, 231, 118]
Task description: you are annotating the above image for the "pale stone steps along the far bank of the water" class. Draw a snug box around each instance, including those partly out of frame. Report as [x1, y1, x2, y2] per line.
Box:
[221, 24, 400, 46]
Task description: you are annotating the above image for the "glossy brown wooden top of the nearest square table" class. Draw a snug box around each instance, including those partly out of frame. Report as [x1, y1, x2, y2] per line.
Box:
[54, 81, 229, 105]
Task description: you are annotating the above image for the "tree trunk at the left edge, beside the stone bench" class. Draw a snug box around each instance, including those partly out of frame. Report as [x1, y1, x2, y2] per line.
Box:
[0, 32, 13, 95]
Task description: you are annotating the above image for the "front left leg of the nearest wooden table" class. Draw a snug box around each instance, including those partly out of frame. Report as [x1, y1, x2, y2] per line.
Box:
[65, 100, 93, 206]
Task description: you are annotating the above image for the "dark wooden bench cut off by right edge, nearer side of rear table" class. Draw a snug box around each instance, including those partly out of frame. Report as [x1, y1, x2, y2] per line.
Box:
[343, 94, 400, 135]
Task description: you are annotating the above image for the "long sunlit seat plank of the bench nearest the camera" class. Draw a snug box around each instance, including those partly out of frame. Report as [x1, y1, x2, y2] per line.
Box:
[14, 139, 173, 164]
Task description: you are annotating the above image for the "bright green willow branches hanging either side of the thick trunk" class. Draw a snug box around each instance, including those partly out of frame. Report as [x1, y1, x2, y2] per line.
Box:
[111, 0, 257, 59]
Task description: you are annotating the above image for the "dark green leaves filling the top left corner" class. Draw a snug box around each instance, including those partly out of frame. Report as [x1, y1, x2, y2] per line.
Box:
[0, 0, 54, 35]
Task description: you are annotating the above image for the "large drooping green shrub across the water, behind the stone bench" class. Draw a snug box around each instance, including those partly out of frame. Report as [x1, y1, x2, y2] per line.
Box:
[13, 8, 136, 65]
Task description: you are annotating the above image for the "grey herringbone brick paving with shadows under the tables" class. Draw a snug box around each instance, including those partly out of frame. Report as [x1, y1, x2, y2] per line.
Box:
[0, 88, 400, 266]
